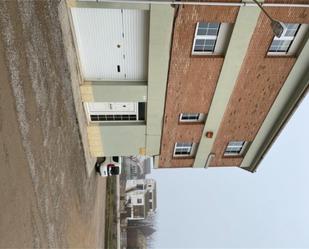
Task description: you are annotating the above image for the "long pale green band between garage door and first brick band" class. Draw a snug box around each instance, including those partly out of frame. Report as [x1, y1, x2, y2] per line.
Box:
[146, 4, 175, 155]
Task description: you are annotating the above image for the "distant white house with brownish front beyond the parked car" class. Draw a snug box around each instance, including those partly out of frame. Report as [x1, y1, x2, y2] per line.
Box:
[126, 179, 157, 220]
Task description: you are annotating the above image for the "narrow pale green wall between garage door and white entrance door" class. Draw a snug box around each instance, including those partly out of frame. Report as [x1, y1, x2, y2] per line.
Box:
[92, 81, 147, 102]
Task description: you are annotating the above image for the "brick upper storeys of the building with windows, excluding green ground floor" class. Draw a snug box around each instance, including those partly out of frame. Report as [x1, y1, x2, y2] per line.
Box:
[159, 1, 309, 171]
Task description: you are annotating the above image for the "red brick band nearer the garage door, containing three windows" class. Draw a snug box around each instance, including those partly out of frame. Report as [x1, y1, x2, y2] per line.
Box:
[159, 1, 238, 167]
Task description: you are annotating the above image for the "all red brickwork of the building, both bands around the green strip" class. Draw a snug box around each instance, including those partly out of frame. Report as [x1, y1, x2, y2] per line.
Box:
[159, 0, 309, 168]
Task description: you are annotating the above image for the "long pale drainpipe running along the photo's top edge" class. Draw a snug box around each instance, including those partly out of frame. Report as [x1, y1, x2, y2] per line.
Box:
[99, 0, 309, 8]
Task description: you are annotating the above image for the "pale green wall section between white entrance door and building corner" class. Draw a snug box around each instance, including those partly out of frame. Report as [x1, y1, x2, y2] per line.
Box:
[100, 124, 146, 156]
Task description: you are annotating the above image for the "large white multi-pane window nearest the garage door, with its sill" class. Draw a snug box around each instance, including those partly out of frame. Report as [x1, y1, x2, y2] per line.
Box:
[192, 22, 233, 55]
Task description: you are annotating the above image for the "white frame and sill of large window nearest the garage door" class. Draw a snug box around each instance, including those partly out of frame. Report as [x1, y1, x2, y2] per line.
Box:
[191, 21, 233, 55]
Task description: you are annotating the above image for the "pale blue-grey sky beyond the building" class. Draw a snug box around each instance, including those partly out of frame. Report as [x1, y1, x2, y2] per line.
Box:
[149, 93, 309, 249]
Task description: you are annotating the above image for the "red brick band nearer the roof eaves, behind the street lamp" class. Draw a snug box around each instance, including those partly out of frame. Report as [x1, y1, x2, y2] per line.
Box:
[210, 4, 309, 166]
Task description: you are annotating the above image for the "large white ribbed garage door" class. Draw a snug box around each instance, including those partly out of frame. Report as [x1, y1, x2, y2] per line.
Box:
[71, 8, 149, 80]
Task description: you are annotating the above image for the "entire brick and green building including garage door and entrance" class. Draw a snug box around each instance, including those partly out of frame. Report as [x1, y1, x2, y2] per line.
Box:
[67, 0, 309, 172]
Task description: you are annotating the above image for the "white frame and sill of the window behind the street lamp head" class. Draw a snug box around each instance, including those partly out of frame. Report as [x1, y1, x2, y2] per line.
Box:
[267, 23, 309, 56]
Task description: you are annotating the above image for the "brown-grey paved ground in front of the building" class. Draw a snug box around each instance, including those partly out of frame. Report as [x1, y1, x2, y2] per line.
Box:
[0, 0, 106, 248]
